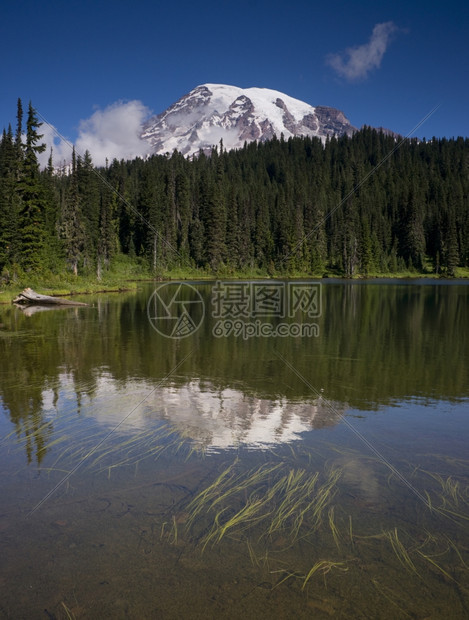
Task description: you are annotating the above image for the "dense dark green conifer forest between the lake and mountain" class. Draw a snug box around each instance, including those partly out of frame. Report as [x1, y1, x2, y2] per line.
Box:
[0, 100, 469, 282]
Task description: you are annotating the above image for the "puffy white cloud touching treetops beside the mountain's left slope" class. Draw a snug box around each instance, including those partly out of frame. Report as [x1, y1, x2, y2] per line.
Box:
[75, 101, 150, 166]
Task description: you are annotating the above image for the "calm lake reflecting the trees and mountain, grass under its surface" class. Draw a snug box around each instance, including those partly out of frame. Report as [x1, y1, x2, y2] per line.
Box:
[0, 280, 469, 620]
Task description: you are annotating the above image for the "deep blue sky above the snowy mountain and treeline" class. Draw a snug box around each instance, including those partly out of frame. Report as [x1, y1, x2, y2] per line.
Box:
[0, 0, 469, 165]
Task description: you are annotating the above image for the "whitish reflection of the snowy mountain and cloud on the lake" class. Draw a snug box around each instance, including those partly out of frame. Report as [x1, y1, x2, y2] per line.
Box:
[43, 376, 344, 449]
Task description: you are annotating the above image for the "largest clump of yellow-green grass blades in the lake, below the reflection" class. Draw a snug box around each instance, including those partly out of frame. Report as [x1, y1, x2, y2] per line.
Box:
[182, 459, 341, 550]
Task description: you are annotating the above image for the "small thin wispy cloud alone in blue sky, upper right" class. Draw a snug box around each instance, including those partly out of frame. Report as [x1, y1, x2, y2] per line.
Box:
[326, 22, 398, 82]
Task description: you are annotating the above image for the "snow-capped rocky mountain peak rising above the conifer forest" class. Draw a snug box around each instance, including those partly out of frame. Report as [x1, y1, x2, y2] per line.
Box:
[141, 84, 356, 156]
